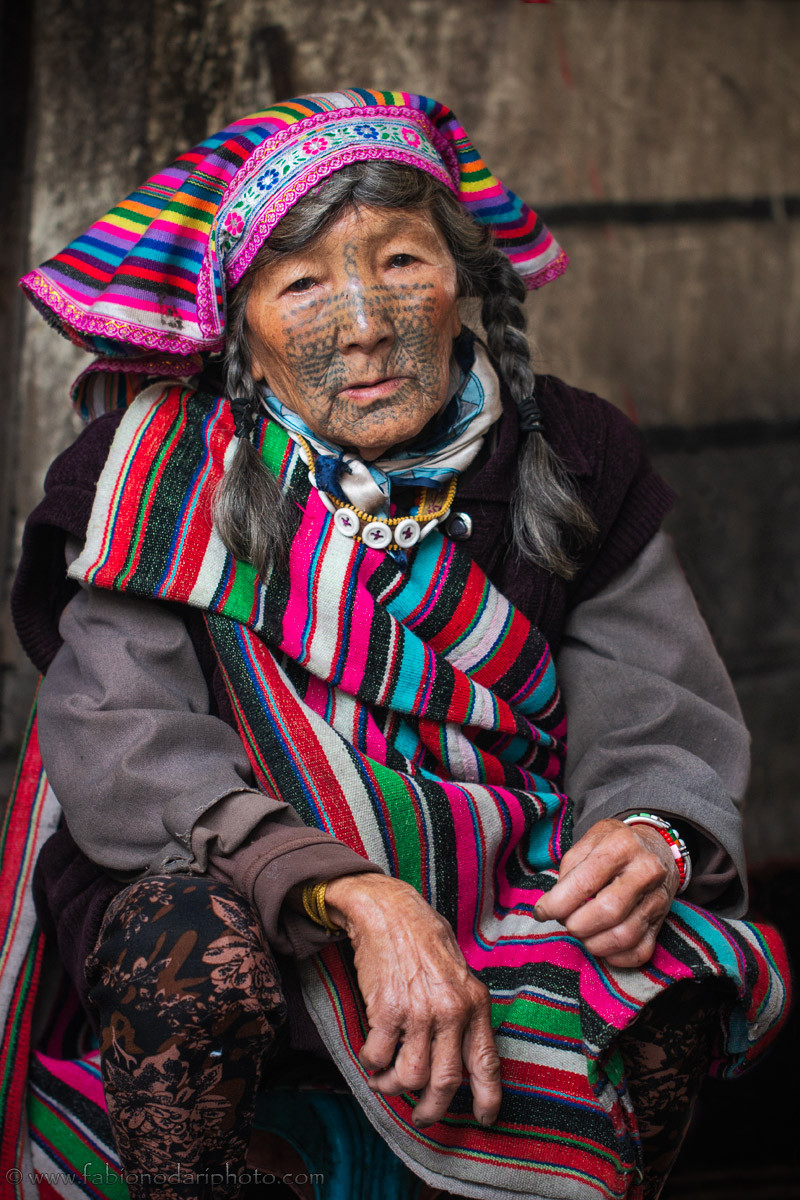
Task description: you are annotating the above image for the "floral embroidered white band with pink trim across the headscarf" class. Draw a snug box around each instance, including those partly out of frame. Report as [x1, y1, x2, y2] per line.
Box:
[215, 106, 458, 288]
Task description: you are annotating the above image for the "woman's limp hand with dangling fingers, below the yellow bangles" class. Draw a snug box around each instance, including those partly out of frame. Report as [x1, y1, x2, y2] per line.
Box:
[325, 875, 500, 1128]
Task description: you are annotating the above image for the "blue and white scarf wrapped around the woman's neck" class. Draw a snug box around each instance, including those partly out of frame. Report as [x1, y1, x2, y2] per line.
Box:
[261, 341, 503, 516]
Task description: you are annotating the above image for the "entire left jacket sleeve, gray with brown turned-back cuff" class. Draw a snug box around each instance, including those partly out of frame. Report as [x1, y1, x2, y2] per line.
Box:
[38, 578, 380, 956]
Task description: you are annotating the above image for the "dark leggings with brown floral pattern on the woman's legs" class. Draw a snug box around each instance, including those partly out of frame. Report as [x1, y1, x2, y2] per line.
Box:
[86, 875, 722, 1200]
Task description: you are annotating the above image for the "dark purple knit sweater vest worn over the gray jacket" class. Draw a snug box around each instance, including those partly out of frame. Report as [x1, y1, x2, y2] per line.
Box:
[12, 377, 674, 1019]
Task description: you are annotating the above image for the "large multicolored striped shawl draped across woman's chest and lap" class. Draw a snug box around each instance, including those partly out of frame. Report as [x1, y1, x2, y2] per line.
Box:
[57, 386, 786, 1200]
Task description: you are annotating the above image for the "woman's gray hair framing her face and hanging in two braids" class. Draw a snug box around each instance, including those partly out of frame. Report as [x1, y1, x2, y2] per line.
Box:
[213, 162, 597, 580]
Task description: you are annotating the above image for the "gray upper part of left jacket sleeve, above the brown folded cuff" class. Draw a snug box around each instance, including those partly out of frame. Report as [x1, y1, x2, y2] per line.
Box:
[37, 588, 268, 880]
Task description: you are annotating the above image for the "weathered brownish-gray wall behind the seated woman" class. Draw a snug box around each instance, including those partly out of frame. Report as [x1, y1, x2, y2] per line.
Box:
[0, 0, 800, 860]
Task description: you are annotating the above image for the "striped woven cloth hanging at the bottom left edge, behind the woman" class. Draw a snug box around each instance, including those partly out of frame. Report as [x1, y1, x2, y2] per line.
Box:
[0, 716, 128, 1200]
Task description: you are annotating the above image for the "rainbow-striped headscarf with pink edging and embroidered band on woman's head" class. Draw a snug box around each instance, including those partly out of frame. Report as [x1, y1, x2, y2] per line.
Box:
[22, 88, 567, 376]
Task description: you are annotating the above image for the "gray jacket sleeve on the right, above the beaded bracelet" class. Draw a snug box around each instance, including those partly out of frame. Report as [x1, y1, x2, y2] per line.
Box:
[557, 533, 750, 916]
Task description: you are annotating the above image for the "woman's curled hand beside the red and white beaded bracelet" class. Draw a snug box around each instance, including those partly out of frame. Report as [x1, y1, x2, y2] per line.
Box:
[535, 820, 680, 967]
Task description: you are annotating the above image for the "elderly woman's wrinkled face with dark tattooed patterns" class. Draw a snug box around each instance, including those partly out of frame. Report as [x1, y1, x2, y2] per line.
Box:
[247, 209, 461, 460]
